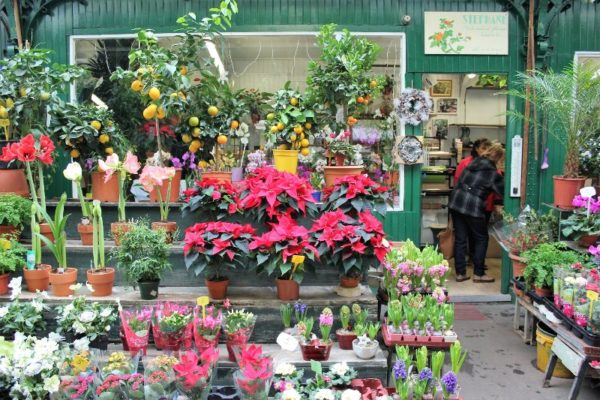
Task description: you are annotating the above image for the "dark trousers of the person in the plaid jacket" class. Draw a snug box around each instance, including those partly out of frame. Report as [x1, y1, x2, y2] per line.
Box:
[451, 210, 489, 276]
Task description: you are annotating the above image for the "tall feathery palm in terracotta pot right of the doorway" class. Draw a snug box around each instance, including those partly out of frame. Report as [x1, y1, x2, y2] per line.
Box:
[506, 64, 600, 208]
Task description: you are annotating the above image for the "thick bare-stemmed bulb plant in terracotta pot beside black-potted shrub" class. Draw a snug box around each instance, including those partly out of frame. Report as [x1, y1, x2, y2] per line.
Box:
[87, 200, 115, 297]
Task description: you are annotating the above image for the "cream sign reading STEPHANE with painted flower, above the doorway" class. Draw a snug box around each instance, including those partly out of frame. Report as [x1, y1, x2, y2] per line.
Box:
[425, 11, 508, 55]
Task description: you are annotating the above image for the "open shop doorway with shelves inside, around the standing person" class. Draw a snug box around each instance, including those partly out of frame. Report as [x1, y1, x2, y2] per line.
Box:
[421, 73, 507, 296]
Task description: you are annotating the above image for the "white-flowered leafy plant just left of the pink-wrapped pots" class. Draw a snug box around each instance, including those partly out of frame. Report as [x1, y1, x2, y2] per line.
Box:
[56, 296, 117, 342]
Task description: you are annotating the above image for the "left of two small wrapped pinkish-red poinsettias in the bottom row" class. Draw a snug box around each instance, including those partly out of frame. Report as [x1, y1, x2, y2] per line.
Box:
[173, 347, 219, 399]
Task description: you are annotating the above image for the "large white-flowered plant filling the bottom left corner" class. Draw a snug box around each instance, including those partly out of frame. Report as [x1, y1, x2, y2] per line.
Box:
[0, 332, 63, 400]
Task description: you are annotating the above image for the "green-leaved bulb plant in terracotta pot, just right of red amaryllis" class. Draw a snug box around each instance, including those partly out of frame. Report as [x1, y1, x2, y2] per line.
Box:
[34, 193, 77, 297]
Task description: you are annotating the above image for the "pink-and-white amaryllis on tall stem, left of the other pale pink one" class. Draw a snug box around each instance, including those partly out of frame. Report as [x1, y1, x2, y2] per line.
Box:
[98, 151, 140, 246]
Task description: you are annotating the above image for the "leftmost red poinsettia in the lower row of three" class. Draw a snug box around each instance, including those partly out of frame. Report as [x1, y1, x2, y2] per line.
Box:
[183, 222, 255, 281]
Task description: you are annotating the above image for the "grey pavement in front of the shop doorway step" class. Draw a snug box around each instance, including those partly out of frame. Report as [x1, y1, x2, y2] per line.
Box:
[456, 303, 600, 400]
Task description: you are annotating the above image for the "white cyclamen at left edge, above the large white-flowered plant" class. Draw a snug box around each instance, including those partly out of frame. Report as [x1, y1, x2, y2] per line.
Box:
[0, 277, 48, 336]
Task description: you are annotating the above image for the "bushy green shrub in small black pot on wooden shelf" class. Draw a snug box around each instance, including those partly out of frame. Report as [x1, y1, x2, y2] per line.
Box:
[113, 221, 171, 300]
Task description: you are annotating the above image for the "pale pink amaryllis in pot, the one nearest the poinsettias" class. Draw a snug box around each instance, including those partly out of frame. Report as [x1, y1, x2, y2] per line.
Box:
[140, 164, 177, 243]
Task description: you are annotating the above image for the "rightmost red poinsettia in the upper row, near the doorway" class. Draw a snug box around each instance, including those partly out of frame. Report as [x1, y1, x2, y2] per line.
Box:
[324, 175, 389, 216]
